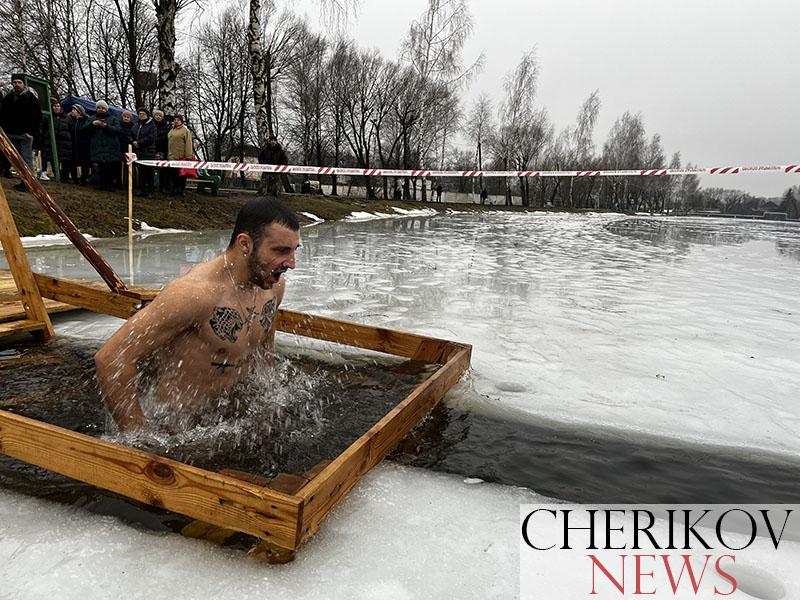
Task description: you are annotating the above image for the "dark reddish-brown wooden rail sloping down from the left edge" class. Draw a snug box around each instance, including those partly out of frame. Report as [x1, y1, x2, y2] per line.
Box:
[0, 129, 127, 292]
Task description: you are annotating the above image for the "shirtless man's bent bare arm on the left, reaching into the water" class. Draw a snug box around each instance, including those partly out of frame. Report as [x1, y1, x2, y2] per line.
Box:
[95, 280, 208, 431]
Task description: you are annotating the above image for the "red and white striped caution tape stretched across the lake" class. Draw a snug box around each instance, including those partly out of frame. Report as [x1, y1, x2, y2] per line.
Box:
[125, 154, 800, 177]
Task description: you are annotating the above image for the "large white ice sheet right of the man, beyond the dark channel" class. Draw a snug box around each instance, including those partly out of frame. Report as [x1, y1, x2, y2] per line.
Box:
[287, 214, 800, 455]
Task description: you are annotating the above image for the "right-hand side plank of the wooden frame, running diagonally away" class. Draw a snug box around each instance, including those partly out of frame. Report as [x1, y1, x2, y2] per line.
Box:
[297, 347, 470, 540]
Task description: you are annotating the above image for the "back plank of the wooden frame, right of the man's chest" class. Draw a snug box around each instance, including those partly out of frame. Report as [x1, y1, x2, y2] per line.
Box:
[277, 309, 465, 364]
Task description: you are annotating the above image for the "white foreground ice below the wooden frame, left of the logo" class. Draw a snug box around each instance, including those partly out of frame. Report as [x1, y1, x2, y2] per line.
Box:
[0, 463, 538, 600]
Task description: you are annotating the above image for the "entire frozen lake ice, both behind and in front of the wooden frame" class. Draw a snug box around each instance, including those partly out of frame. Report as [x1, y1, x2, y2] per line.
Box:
[0, 213, 800, 598]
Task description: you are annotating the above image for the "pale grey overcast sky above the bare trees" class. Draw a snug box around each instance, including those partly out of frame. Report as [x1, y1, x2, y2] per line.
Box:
[290, 0, 800, 196]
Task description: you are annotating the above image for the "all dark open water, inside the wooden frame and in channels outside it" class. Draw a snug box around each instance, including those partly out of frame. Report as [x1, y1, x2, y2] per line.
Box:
[0, 332, 800, 530]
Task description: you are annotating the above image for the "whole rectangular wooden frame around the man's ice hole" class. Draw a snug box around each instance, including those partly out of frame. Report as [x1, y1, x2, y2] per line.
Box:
[0, 282, 472, 562]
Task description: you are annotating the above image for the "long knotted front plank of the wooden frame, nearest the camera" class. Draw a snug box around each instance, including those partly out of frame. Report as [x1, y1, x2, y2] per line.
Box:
[0, 411, 302, 549]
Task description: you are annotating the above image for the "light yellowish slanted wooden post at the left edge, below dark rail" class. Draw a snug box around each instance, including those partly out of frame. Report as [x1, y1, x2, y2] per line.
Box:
[0, 183, 55, 341]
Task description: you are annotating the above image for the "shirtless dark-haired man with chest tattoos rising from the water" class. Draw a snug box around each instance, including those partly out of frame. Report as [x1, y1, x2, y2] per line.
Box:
[95, 198, 300, 431]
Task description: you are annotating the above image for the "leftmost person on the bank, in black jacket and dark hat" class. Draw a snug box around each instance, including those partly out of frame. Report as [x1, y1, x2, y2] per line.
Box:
[0, 73, 42, 192]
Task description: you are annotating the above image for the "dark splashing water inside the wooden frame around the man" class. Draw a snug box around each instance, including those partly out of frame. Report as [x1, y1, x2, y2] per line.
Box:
[0, 340, 432, 476]
